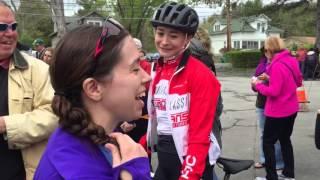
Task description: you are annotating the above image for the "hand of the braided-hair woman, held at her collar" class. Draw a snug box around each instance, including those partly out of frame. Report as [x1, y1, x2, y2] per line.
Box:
[105, 133, 148, 167]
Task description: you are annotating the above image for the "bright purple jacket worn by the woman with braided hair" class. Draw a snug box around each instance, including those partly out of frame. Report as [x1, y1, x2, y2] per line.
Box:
[34, 128, 151, 180]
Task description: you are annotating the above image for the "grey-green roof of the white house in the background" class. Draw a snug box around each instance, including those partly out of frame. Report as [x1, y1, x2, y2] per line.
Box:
[209, 14, 283, 35]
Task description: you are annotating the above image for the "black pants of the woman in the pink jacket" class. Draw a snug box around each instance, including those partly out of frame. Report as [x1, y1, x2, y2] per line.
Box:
[263, 113, 297, 180]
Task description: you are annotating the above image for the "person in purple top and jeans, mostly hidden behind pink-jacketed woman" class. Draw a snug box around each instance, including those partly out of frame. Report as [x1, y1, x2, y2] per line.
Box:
[253, 47, 284, 169]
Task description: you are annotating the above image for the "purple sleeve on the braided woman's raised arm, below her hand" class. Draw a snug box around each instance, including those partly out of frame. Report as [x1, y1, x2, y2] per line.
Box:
[112, 157, 151, 180]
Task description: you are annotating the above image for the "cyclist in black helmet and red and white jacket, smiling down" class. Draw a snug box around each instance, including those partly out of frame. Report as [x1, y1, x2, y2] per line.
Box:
[147, 2, 220, 180]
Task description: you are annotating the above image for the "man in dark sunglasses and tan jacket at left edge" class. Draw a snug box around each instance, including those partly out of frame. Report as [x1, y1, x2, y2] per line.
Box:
[0, 0, 57, 180]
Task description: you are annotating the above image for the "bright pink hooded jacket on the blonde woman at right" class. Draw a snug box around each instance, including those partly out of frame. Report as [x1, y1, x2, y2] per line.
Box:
[255, 50, 302, 118]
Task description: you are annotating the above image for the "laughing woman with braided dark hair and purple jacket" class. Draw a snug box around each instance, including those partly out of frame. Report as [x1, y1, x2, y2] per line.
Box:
[34, 18, 151, 180]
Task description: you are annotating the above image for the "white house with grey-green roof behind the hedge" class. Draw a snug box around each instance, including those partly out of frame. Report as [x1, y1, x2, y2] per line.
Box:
[209, 14, 283, 54]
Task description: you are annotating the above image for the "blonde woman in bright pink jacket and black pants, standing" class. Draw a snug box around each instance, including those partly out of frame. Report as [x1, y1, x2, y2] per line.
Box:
[252, 37, 302, 180]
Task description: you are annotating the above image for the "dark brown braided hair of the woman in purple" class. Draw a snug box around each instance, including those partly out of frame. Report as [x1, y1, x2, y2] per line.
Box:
[50, 25, 129, 144]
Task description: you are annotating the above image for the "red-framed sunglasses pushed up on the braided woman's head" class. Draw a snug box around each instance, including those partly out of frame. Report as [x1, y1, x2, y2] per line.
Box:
[94, 17, 124, 59]
